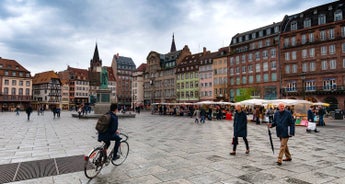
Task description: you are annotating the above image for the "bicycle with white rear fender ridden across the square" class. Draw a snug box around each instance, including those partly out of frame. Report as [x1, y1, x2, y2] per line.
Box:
[84, 133, 129, 179]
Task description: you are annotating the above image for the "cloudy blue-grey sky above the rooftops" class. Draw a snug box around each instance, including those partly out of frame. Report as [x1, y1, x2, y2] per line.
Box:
[0, 0, 334, 75]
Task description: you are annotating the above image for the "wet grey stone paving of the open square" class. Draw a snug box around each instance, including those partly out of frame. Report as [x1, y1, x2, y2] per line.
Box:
[0, 112, 345, 184]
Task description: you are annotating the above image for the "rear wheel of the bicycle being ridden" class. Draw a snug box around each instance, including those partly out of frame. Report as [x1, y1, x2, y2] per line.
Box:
[84, 148, 104, 179]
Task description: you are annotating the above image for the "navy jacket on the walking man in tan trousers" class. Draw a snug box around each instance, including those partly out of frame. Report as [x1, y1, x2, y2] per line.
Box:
[272, 110, 295, 138]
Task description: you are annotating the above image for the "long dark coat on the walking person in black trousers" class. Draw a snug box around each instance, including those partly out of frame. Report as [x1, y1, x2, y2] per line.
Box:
[234, 111, 247, 137]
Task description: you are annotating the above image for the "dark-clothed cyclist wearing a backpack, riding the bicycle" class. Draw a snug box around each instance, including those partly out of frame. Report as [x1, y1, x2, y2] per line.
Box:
[98, 103, 121, 160]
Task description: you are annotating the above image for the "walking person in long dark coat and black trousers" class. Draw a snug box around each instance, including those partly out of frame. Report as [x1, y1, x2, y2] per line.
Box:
[230, 105, 249, 155]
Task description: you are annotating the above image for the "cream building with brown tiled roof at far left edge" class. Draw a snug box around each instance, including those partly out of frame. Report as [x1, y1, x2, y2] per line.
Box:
[0, 57, 32, 111]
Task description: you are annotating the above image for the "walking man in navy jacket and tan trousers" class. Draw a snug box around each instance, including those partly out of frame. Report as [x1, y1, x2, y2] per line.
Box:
[268, 103, 295, 165]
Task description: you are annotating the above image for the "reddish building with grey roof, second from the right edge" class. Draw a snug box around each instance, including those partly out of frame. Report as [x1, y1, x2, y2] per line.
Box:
[228, 23, 280, 101]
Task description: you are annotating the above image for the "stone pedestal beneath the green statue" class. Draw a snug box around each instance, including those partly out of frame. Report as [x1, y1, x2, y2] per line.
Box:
[95, 89, 111, 114]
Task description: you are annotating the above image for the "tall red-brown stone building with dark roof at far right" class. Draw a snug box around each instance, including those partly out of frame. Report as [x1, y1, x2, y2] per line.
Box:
[280, 1, 345, 109]
